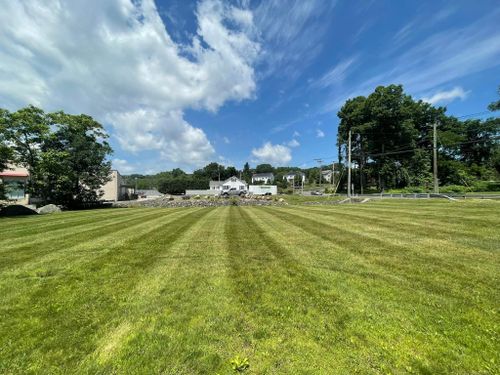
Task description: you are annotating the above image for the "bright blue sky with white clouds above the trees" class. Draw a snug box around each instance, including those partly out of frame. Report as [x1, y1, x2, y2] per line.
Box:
[0, 0, 500, 173]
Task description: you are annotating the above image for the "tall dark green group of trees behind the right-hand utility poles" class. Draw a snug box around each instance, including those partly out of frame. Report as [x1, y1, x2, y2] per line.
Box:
[337, 85, 500, 191]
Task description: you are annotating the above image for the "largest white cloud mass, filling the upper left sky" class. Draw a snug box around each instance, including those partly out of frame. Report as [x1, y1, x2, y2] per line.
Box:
[0, 0, 260, 165]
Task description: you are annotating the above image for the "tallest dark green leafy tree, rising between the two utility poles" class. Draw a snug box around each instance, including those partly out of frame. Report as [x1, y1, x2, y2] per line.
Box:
[338, 85, 444, 189]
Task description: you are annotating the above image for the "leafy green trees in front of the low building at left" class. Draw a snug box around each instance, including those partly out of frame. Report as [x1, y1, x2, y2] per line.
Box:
[0, 106, 112, 207]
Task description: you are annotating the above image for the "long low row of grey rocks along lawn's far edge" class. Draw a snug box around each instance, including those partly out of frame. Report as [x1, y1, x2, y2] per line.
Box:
[113, 196, 288, 207]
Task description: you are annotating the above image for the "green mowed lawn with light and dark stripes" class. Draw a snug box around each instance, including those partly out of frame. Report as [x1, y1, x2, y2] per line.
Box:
[0, 200, 500, 375]
